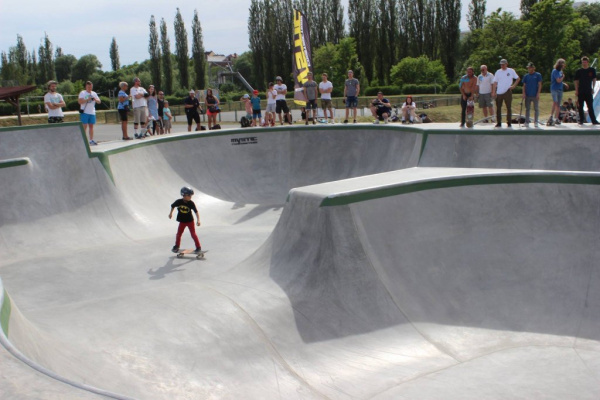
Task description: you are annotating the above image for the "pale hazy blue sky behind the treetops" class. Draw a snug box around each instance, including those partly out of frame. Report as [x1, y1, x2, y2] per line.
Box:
[0, 0, 520, 70]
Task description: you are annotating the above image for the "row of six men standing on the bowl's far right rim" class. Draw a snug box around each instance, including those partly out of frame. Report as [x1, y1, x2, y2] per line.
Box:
[459, 57, 600, 128]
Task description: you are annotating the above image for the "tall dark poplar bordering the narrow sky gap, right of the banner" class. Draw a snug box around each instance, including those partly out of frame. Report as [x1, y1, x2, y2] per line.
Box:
[435, 0, 461, 77]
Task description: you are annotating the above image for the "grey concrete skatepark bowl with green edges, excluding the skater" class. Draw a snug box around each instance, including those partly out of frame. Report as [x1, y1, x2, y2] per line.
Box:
[0, 123, 600, 399]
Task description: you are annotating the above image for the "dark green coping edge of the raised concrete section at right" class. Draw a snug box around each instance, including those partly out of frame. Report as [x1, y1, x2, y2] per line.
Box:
[321, 173, 600, 207]
